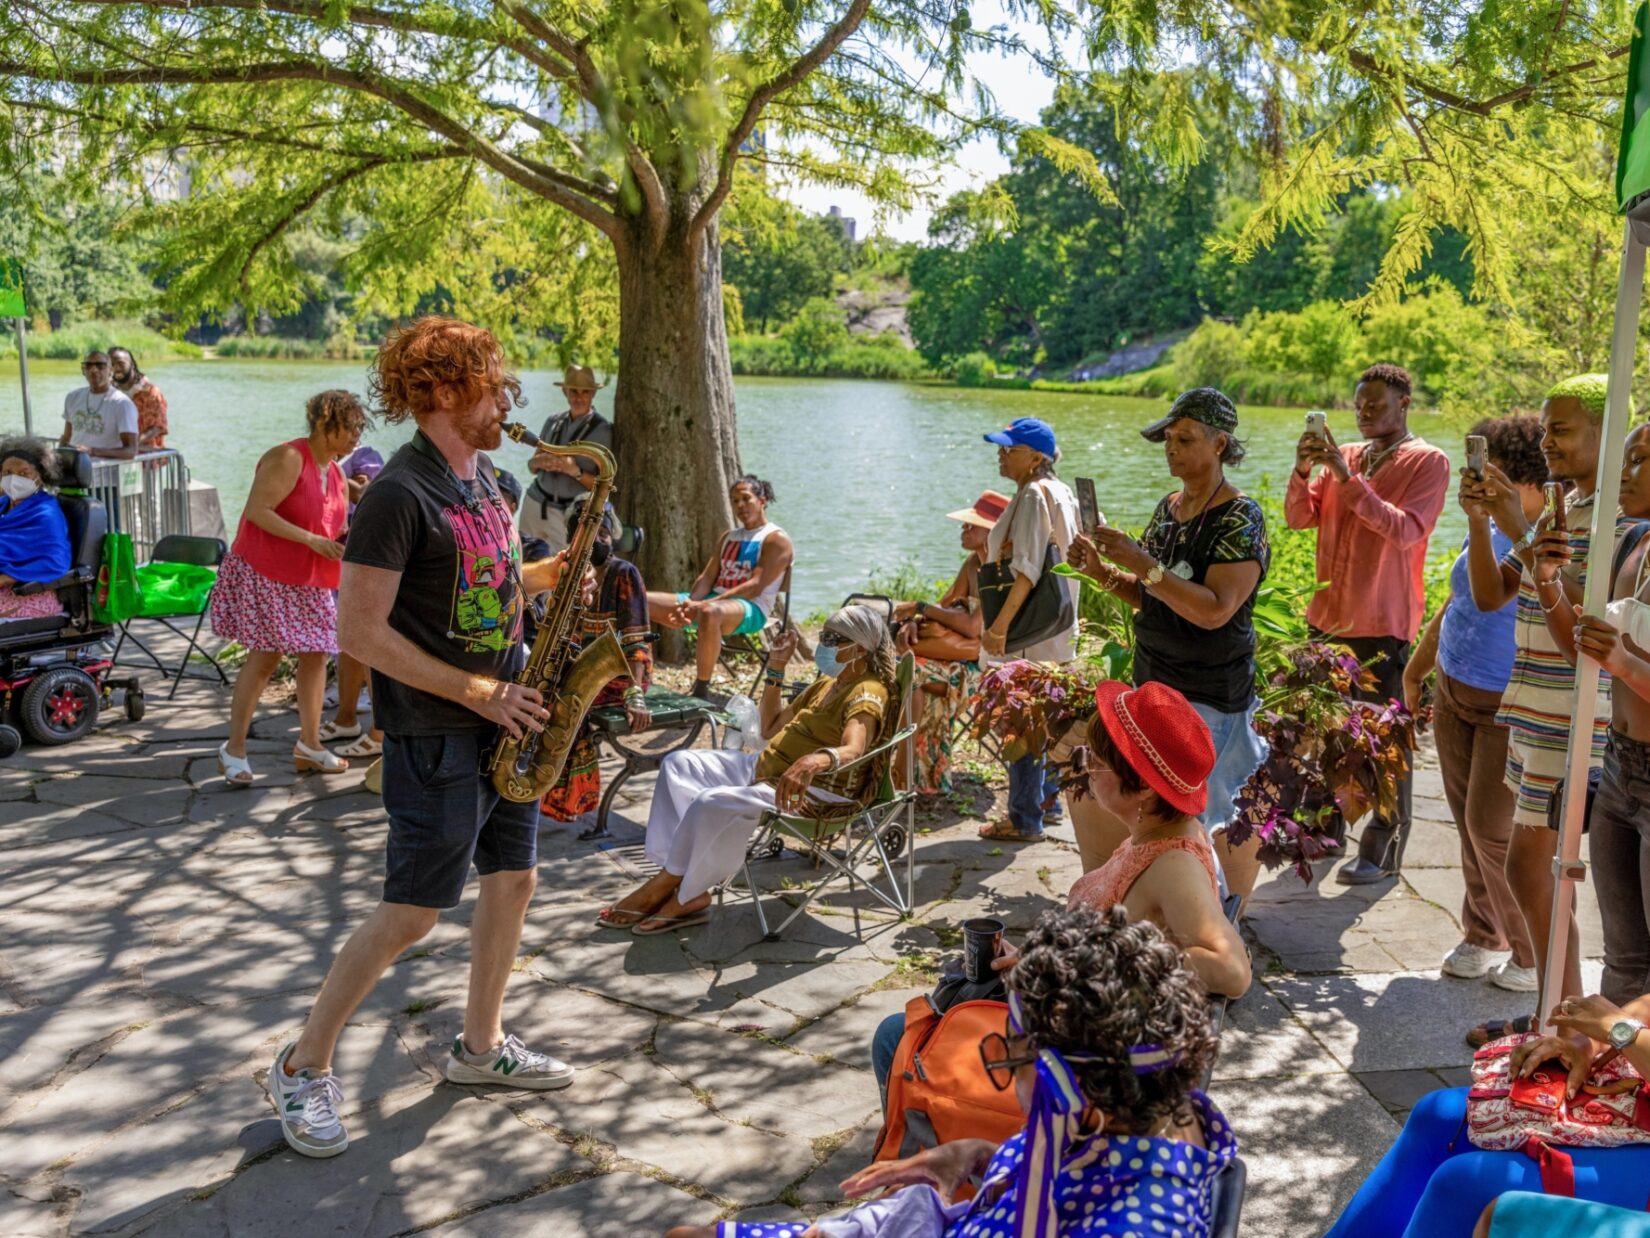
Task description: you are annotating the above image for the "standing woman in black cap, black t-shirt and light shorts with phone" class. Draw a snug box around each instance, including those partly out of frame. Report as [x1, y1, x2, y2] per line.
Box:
[1069, 386, 1272, 896]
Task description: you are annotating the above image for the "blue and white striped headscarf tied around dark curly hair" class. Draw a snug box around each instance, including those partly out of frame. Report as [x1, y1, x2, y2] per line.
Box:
[1008, 990, 1180, 1238]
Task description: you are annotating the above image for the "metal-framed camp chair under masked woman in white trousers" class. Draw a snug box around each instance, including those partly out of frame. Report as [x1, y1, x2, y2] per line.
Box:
[729, 654, 916, 941]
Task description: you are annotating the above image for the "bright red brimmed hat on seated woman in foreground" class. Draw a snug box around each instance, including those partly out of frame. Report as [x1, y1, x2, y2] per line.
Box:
[1094, 680, 1214, 817]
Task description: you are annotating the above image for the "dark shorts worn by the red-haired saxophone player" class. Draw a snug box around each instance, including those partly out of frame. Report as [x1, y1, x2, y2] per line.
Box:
[383, 731, 538, 908]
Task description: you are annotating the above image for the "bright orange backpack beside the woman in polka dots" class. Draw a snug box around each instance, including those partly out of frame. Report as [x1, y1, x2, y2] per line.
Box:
[871, 994, 1026, 1175]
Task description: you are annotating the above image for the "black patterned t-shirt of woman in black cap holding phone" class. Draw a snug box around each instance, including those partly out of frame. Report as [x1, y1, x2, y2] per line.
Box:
[1134, 495, 1272, 713]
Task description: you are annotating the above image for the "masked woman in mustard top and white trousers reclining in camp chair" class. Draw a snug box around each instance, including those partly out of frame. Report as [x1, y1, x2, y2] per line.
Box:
[596, 606, 896, 934]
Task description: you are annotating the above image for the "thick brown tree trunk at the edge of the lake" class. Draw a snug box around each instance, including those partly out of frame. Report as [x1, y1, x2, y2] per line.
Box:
[614, 206, 739, 660]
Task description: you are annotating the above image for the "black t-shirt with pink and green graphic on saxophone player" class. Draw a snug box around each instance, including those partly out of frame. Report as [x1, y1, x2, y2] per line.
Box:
[343, 434, 526, 735]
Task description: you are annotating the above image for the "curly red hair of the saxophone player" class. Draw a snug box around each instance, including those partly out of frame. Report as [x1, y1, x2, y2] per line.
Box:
[366, 314, 526, 424]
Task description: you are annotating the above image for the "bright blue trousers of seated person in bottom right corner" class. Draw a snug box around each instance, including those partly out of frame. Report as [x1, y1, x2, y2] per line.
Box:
[1327, 1088, 1650, 1238]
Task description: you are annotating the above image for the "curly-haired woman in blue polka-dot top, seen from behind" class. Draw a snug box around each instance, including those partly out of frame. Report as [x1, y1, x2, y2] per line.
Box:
[667, 908, 1238, 1238]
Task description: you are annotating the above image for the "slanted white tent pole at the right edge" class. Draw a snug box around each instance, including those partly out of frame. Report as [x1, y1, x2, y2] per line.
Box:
[1536, 220, 1645, 1022]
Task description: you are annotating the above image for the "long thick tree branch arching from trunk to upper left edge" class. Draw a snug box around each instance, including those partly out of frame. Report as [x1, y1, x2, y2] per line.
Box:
[0, 61, 619, 236]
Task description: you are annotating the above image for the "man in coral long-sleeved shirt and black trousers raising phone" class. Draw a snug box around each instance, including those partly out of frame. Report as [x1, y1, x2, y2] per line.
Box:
[1284, 365, 1450, 885]
